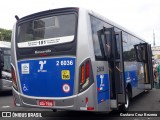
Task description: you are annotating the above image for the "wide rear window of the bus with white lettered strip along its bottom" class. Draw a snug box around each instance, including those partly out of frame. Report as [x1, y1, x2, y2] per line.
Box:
[17, 13, 76, 48]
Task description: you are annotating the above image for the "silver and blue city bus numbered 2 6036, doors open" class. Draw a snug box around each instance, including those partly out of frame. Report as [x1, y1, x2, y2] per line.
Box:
[11, 7, 153, 112]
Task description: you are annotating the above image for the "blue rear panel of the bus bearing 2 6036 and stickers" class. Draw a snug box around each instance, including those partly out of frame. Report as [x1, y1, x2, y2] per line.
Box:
[18, 57, 76, 97]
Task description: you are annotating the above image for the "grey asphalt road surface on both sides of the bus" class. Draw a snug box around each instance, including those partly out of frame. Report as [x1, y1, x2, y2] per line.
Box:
[0, 89, 160, 120]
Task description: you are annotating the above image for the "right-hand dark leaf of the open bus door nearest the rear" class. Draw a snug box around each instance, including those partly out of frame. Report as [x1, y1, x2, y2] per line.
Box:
[113, 32, 126, 104]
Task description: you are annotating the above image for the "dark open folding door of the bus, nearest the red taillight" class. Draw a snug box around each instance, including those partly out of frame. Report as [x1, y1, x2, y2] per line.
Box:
[104, 28, 126, 109]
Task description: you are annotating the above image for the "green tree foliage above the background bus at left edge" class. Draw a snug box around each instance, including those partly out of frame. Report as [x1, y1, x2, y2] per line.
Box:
[0, 28, 12, 42]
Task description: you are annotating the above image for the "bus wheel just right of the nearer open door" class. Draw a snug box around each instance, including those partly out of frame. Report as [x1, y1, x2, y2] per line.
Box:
[119, 90, 130, 112]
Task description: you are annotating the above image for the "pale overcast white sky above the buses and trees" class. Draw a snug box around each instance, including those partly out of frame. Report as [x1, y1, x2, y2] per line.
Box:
[0, 0, 160, 45]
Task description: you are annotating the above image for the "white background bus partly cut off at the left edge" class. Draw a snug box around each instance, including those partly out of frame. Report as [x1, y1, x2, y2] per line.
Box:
[0, 41, 12, 91]
